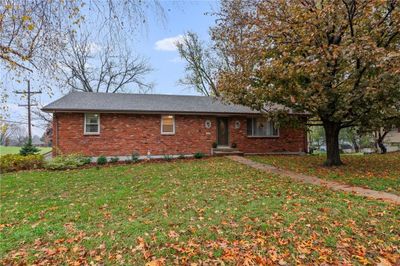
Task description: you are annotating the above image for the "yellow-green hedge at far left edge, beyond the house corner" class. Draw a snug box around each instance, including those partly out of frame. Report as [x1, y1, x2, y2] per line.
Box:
[0, 154, 44, 173]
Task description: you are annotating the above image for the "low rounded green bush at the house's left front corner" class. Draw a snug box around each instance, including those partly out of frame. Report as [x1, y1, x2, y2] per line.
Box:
[44, 154, 91, 170]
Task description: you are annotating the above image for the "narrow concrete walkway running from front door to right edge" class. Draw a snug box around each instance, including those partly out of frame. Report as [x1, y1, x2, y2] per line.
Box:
[227, 156, 400, 205]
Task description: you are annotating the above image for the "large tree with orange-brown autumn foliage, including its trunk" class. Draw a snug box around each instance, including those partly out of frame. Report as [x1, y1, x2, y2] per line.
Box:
[212, 0, 400, 165]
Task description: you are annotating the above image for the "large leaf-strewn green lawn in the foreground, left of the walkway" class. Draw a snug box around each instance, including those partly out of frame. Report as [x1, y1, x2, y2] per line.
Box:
[0, 158, 400, 265]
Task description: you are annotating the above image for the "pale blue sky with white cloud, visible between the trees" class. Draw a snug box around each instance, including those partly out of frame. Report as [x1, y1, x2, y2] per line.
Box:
[3, 0, 218, 136]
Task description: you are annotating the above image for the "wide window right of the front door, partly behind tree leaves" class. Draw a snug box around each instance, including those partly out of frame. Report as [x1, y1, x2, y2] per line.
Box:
[247, 118, 279, 137]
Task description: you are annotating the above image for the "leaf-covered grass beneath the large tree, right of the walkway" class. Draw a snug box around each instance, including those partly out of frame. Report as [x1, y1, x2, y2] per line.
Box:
[251, 153, 400, 195]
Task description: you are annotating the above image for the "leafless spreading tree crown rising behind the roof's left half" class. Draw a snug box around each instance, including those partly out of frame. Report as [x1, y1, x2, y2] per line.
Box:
[60, 33, 152, 93]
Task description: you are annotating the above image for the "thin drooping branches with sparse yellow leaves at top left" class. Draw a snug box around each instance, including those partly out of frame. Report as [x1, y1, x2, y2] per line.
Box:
[0, 0, 165, 72]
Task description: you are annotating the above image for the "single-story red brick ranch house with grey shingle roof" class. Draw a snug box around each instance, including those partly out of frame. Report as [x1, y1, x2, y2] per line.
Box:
[42, 92, 307, 159]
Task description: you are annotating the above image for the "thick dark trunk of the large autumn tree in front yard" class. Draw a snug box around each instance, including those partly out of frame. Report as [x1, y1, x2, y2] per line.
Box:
[323, 121, 343, 166]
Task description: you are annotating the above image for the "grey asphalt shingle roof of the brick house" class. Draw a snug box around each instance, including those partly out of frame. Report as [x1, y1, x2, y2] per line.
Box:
[42, 92, 259, 114]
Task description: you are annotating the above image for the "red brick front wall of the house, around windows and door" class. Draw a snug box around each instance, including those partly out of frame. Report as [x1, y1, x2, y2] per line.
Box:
[53, 113, 306, 156]
